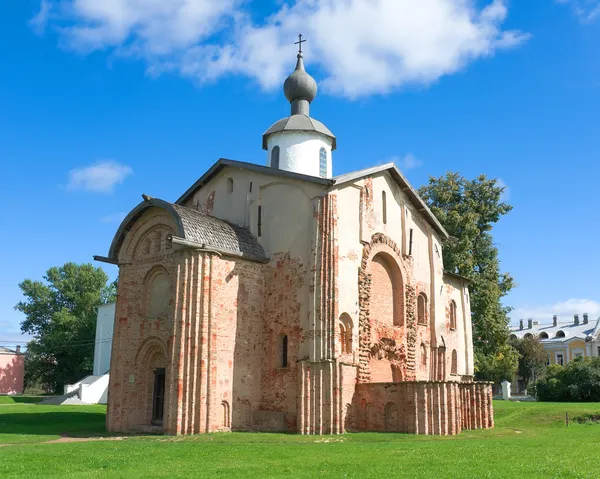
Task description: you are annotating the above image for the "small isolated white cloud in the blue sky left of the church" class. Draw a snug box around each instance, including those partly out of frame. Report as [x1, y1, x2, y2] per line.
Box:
[67, 161, 133, 193]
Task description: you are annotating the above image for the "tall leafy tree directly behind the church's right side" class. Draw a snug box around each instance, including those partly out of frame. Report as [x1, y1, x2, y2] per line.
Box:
[419, 172, 517, 380]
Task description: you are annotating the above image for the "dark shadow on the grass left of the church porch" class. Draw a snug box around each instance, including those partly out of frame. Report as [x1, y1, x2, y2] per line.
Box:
[0, 407, 110, 442]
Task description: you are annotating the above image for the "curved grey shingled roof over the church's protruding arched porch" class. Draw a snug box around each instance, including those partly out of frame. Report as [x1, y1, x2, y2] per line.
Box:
[109, 198, 269, 262]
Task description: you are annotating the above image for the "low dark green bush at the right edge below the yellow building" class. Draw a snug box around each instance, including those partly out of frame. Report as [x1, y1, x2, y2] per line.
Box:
[533, 358, 600, 402]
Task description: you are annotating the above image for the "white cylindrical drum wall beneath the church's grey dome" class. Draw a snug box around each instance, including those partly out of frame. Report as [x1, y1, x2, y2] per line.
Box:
[267, 131, 332, 178]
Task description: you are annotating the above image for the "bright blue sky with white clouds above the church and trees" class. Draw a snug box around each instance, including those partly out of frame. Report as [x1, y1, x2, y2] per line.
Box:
[0, 0, 600, 346]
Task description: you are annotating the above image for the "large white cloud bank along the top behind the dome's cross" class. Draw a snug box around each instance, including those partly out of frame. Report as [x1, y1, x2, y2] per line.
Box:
[32, 0, 529, 98]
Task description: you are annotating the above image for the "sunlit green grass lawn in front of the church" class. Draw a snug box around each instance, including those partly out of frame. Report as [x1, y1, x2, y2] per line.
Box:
[0, 401, 600, 479]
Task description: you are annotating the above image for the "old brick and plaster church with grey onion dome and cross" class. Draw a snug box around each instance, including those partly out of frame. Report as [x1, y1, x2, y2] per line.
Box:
[95, 43, 494, 435]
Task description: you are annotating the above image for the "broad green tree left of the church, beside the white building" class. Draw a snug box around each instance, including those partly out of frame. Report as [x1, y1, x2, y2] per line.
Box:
[15, 263, 116, 392]
